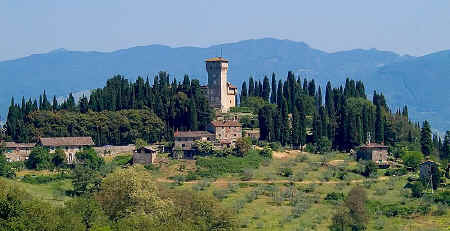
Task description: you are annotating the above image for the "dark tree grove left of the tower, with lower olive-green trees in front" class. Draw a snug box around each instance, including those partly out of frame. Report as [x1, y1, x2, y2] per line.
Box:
[6, 72, 214, 145]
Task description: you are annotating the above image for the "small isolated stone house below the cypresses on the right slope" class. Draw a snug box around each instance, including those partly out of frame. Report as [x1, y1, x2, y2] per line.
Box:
[356, 143, 389, 165]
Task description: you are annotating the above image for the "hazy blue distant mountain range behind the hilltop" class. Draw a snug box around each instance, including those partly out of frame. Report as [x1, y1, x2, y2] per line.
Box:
[0, 38, 450, 131]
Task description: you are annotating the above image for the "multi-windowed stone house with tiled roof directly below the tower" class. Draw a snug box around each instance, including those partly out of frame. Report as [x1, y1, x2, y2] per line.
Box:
[207, 120, 242, 145]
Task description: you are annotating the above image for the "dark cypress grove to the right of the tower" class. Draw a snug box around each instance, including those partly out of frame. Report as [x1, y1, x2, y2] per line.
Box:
[240, 72, 420, 150]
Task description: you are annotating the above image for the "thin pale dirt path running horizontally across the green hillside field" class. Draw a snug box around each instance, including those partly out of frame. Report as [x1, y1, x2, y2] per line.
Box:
[156, 176, 389, 185]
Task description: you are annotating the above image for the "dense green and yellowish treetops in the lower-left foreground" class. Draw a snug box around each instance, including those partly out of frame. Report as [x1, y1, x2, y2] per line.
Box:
[0, 168, 236, 231]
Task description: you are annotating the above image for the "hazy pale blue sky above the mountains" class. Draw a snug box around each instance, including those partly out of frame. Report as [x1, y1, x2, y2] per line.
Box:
[0, 0, 450, 60]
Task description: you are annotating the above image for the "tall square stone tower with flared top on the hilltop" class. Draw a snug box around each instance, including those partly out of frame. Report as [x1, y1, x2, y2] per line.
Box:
[206, 57, 237, 112]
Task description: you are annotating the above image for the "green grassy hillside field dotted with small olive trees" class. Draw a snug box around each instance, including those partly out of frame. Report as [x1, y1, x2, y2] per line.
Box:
[7, 151, 450, 231]
